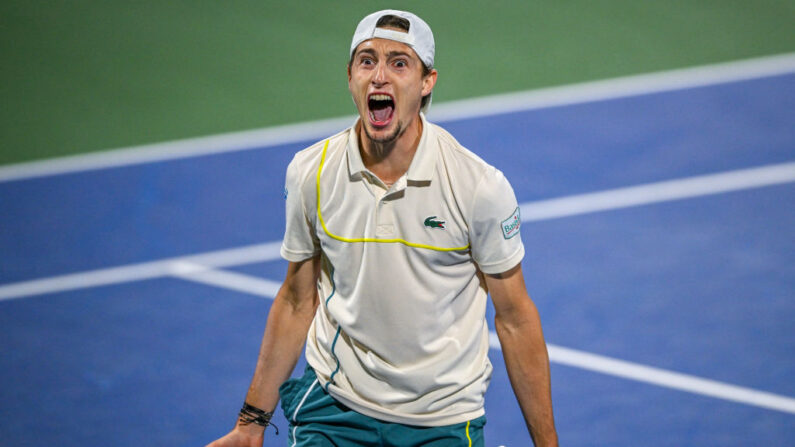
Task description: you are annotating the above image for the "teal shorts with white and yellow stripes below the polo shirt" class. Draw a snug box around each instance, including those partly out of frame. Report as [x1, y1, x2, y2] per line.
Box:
[279, 367, 486, 447]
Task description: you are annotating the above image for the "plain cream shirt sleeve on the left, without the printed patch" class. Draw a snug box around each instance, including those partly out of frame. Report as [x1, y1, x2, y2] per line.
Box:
[281, 158, 320, 262]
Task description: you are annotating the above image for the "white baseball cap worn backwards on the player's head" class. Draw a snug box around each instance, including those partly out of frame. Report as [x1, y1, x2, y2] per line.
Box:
[350, 9, 436, 68]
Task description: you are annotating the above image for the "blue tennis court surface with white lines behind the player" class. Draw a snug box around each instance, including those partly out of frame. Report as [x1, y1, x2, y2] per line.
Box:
[0, 62, 795, 447]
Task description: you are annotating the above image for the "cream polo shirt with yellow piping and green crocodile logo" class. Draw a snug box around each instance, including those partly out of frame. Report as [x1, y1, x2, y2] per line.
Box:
[281, 115, 524, 426]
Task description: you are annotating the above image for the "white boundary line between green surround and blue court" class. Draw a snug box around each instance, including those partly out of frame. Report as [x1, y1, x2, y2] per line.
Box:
[0, 53, 795, 182]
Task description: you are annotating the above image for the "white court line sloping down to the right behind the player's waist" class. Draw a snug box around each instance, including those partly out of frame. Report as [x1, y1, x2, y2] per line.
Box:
[173, 262, 795, 414]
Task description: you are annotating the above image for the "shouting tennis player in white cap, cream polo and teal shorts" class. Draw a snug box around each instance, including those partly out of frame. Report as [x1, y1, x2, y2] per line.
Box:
[210, 10, 557, 447]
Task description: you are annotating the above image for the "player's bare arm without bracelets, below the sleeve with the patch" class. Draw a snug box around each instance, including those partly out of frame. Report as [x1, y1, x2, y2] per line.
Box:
[484, 264, 558, 447]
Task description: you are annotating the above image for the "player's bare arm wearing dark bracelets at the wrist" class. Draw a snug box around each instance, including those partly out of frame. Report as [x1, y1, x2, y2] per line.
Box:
[208, 256, 320, 447]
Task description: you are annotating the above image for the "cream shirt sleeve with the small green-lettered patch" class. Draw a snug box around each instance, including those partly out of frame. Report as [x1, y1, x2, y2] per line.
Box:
[470, 168, 524, 274]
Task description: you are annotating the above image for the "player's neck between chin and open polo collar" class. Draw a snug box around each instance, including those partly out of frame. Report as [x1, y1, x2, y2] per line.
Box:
[358, 115, 422, 185]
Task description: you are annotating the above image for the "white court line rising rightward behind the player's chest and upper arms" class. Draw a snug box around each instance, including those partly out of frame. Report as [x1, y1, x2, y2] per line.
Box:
[0, 162, 795, 301]
